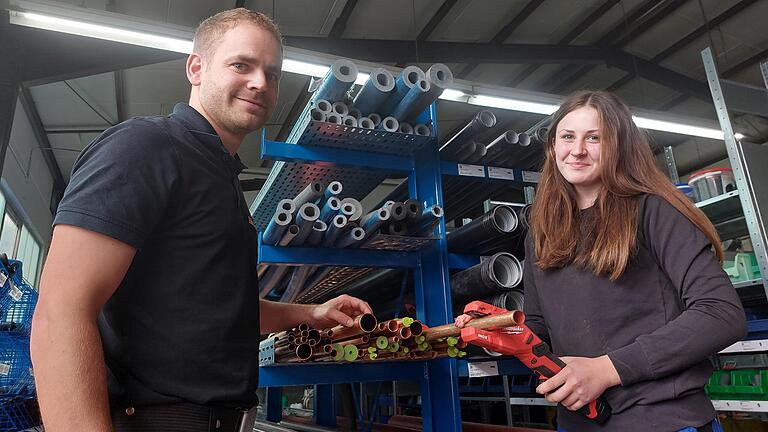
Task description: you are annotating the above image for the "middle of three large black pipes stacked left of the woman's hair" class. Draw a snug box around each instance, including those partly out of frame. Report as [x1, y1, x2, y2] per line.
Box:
[451, 252, 523, 299]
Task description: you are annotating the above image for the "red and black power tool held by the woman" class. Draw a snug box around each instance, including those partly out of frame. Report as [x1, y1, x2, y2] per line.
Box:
[461, 301, 611, 424]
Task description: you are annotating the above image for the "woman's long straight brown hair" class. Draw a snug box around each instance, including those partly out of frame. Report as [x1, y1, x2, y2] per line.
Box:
[530, 91, 723, 281]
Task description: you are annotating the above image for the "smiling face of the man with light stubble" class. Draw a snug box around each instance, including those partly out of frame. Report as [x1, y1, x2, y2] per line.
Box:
[199, 23, 283, 136]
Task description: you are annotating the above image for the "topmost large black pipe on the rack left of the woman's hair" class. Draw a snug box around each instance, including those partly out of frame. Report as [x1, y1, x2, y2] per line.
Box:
[446, 205, 526, 254]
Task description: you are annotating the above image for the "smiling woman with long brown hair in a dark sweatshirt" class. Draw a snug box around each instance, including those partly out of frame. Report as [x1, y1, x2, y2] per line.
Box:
[462, 91, 746, 432]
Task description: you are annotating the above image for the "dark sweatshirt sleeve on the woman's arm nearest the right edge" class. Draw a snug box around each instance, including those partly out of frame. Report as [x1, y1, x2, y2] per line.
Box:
[608, 196, 746, 386]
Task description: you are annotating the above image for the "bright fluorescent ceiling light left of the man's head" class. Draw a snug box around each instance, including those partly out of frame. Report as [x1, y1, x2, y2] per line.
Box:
[9, 10, 192, 54]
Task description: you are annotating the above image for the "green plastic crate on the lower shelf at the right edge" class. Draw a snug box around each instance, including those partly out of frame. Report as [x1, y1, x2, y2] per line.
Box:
[705, 369, 768, 400]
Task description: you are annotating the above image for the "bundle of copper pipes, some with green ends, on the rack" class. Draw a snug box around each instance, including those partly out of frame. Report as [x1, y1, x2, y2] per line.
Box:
[260, 314, 466, 363]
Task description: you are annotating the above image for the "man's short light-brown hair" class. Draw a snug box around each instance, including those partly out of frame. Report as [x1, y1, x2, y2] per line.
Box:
[192, 8, 283, 56]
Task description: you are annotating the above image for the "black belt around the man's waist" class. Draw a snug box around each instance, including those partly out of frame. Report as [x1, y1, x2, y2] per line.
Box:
[112, 403, 248, 432]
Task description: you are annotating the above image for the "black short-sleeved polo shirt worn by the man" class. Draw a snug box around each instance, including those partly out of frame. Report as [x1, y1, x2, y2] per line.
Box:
[54, 103, 259, 406]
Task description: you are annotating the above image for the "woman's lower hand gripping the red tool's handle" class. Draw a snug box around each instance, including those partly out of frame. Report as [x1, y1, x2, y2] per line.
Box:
[536, 355, 621, 411]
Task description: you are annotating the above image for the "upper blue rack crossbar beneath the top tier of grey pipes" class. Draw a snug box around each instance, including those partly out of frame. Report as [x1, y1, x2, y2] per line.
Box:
[261, 140, 413, 171]
